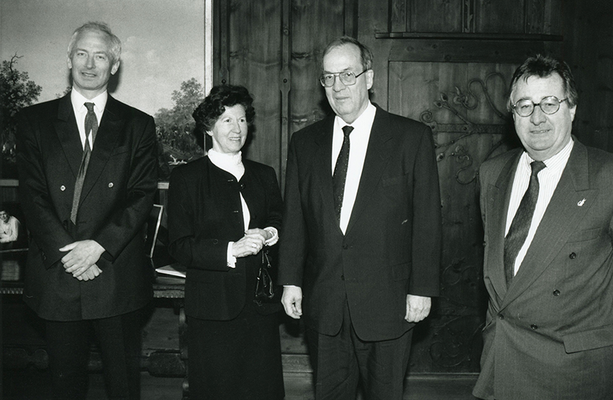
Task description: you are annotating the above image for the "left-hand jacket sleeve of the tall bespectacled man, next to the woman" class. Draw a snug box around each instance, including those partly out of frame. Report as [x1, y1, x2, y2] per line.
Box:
[278, 135, 307, 286]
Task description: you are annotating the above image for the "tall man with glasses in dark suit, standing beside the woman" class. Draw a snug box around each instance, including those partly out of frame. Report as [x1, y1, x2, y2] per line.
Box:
[279, 37, 441, 400]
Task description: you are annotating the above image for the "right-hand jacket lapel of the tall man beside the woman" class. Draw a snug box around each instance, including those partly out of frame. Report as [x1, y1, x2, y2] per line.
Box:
[346, 107, 396, 234]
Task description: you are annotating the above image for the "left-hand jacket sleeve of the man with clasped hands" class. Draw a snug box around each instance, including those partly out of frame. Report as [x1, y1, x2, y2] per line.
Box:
[16, 111, 73, 268]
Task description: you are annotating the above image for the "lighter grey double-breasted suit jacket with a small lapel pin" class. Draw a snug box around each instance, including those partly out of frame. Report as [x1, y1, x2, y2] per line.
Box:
[474, 139, 613, 400]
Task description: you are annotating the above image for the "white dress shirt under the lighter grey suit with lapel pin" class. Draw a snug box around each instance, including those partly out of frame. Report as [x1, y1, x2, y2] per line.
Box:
[505, 139, 575, 274]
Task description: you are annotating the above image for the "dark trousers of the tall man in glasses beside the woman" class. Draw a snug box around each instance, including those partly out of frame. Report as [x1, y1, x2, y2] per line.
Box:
[306, 305, 413, 400]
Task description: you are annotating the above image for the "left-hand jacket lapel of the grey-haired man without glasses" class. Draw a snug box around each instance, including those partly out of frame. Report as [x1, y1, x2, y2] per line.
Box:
[54, 94, 83, 179]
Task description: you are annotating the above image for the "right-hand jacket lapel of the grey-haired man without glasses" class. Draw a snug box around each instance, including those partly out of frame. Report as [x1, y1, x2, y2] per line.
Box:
[81, 96, 124, 201]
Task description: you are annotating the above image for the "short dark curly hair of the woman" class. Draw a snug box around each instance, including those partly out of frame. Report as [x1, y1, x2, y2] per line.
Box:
[192, 85, 255, 149]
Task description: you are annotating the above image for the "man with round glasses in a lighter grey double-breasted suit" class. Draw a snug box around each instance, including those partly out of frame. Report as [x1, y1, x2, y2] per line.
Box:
[473, 55, 613, 400]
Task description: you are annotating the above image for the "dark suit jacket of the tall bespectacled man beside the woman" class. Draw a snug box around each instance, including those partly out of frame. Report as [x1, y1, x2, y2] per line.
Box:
[279, 108, 441, 340]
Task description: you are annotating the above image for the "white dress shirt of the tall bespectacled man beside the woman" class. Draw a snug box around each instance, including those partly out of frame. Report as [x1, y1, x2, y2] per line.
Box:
[332, 101, 377, 233]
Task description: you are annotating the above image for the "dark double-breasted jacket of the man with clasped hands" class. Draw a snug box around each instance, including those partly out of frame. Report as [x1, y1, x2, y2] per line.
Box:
[17, 94, 157, 321]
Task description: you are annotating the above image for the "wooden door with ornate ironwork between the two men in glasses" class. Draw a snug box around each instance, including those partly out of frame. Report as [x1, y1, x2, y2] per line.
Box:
[358, 0, 561, 372]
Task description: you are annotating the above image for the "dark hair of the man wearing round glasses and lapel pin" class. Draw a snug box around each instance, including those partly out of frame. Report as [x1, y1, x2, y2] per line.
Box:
[507, 54, 579, 111]
